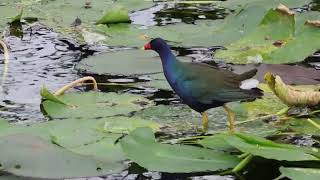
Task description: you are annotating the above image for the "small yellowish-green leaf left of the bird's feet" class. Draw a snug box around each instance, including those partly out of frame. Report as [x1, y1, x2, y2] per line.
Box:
[103, 116, 160, 134]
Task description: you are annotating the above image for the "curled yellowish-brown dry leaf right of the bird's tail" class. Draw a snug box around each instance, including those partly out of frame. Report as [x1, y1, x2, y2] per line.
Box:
[264, 72, 320, 106]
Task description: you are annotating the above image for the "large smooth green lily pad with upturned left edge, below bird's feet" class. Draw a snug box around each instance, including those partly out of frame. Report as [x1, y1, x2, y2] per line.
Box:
[120, 128, 239, 173]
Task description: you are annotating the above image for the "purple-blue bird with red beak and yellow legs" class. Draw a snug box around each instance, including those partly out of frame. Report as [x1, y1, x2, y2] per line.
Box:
[144, 38, 263, 131]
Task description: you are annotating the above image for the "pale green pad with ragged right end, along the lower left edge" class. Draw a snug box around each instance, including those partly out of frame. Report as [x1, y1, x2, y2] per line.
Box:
[0, 118, 126, 166]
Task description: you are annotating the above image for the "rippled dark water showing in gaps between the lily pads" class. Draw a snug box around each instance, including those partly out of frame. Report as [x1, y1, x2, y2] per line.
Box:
[0, 3, 320, 180]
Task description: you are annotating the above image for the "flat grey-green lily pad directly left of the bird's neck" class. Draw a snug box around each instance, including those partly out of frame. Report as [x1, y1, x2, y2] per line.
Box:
[75, 49, 162, 76]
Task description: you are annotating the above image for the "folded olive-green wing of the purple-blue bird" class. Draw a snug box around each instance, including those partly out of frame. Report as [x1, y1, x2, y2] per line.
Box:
[180, 63, 255, 104]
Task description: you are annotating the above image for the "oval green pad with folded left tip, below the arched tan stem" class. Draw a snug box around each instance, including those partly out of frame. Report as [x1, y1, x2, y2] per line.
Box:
[42, 91, 152, 119]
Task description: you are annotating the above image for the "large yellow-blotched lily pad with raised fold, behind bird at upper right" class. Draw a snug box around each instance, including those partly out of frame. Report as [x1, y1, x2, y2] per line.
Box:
[215, 5, 320, 64]
